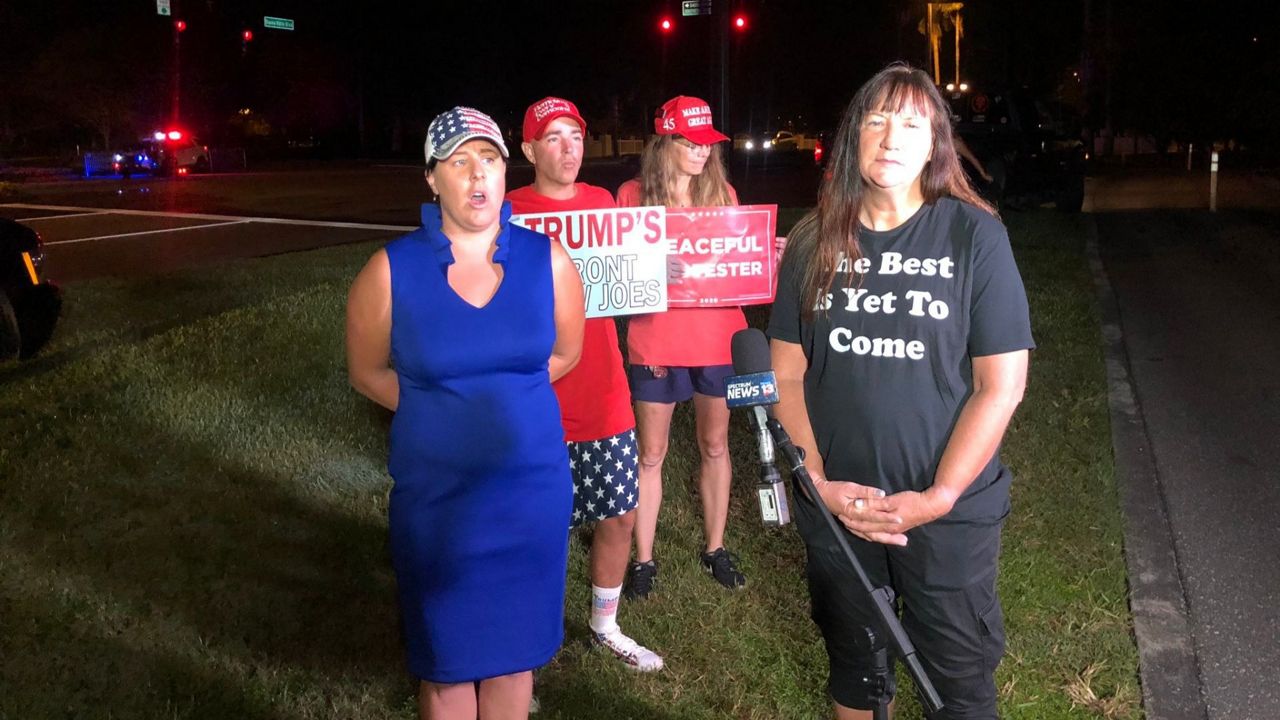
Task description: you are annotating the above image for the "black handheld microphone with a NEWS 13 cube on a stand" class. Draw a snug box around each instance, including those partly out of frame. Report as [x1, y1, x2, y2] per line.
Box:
[724, 328, 791, 527]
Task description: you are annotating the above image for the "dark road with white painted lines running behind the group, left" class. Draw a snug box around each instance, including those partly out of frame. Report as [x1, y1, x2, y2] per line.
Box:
[0, 159, 818, 282]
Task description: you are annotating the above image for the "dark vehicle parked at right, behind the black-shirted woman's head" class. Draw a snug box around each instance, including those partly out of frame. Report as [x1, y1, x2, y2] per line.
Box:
[943, 88, 1084, 211]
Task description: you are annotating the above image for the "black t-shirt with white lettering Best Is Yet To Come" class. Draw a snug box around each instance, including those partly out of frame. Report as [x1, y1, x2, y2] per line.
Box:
[769, 199, 1036, 523]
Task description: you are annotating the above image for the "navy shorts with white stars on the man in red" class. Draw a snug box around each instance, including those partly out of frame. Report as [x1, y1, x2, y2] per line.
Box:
[564, 428, 640, 528]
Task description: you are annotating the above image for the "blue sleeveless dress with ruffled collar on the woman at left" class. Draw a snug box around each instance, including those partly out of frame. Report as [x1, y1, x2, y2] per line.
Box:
[387, 204, 573, 683]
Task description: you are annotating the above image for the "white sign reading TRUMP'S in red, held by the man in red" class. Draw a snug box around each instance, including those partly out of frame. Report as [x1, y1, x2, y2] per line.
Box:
[511, 208, 667, 318]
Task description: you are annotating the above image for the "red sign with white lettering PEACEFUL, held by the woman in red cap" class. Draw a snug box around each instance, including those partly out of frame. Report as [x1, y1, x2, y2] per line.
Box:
[667, 205, 778, 307]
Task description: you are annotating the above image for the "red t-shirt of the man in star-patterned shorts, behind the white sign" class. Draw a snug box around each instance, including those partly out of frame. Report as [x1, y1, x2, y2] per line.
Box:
[507, 182, 636, 442]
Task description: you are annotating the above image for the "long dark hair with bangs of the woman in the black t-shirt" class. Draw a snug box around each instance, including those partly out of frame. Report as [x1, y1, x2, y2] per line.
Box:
[788, 63, 996, 318]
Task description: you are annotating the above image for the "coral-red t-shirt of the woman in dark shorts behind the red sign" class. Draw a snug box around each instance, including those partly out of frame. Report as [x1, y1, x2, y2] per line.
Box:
[618, 174, 746, 368]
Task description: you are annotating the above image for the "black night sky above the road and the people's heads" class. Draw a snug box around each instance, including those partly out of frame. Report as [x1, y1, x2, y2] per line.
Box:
[0, 0, 1280, 155]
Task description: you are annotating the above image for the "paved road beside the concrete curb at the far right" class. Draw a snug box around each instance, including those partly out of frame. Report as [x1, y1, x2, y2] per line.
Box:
[1091, 166, 1280, 720]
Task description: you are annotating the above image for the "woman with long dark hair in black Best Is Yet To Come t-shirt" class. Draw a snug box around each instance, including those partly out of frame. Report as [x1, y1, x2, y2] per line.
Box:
[769, 64, 1034, 719]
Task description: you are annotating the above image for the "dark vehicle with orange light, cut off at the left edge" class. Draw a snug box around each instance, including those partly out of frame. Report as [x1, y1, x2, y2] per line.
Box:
[0, 218, 63, 361]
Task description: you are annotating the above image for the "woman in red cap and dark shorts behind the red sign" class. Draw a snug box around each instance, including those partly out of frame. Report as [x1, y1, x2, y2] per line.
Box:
[618, 96, 746, 598]
